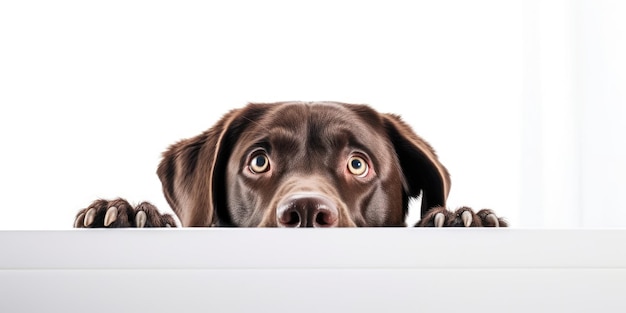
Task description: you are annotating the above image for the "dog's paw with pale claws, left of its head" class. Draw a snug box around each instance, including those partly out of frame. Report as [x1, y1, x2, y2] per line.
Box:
[74, 199, 176, 228]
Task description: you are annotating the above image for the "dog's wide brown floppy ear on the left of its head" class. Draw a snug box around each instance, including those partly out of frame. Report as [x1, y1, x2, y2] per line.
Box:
[157, 104, 268, 226]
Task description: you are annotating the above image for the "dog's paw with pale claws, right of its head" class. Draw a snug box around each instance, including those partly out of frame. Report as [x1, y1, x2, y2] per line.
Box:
[415, 207, 508, 227]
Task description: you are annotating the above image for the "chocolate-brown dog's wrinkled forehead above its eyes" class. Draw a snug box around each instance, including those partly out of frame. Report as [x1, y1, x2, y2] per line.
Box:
[239, 102, 392, 159]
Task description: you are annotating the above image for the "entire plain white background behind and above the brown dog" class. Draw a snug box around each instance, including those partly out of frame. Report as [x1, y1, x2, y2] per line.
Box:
[0, 0, 626, 229]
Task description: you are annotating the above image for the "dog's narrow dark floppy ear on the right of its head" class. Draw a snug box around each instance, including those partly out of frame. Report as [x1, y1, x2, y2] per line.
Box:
[384, 114, 450, 215]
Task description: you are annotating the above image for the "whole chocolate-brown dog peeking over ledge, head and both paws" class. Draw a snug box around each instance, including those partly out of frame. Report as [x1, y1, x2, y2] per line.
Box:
[74, 102, 508, 228]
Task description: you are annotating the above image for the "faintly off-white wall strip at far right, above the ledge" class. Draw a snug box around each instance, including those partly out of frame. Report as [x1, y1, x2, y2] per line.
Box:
[521, 0, 626, 227]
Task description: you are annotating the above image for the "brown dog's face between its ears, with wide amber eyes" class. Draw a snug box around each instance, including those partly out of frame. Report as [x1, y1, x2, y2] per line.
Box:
[226, 104, 404, 226]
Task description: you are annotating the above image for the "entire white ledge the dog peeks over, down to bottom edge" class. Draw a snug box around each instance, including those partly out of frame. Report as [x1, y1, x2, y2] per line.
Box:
[0, 228, 626, 312]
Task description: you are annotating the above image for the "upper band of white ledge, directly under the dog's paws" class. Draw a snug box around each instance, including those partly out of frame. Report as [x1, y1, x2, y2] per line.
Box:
[0, 228, 626, 269]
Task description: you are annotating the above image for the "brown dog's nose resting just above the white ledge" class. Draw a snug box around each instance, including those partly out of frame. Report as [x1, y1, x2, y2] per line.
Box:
[276, 194, 339, 227]
